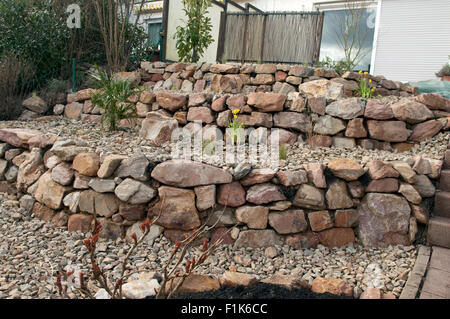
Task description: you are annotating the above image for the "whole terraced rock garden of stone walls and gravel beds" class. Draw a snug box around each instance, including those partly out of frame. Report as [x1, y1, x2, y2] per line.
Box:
[0, 62, 450, 298]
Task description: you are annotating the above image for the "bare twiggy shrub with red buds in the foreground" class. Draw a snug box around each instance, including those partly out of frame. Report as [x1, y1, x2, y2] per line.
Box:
[56, 198, 231, 299]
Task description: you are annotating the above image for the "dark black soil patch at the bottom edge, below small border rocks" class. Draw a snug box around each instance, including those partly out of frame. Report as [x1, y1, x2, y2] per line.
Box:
[163, 282, 353, 299]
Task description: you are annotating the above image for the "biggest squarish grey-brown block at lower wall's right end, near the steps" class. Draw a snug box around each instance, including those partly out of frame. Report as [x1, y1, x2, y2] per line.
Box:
[358, 193, 411, 247]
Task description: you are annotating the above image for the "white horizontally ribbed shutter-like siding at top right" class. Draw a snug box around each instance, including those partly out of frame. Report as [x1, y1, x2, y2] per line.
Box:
[372, 0, 450, 82]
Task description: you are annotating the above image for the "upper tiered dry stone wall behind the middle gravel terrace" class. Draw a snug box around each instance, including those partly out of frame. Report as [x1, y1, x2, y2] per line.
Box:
[46, 62, 450, 151]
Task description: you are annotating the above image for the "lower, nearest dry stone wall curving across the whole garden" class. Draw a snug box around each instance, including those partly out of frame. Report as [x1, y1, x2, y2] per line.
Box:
[0, 129, 442, 248]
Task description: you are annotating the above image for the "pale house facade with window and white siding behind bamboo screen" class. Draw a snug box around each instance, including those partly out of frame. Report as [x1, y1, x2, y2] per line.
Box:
[133, 0, 450, 82]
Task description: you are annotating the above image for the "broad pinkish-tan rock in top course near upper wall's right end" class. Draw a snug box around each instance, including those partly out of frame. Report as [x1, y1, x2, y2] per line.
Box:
[391, 99, 434, 124]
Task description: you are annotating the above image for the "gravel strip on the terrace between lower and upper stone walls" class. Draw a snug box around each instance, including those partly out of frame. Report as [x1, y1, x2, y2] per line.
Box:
[0, 116, 450, 169]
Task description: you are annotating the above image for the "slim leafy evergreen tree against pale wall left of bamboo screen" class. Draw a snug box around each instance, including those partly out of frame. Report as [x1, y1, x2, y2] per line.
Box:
[174, 0, 214, 62]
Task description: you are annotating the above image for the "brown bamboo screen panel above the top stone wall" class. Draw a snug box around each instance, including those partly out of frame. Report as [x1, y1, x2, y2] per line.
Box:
[224, 13, 322, 63]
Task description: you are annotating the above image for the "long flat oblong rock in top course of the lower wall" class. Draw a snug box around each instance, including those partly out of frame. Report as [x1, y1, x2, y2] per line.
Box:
[152, 160, 233, 187]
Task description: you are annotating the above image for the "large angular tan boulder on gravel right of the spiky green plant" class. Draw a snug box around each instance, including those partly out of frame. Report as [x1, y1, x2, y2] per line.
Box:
[139, 112, 178, 146]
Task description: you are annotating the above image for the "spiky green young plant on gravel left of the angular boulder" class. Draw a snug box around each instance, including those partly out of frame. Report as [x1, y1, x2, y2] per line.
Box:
[91, 67, 141, 131]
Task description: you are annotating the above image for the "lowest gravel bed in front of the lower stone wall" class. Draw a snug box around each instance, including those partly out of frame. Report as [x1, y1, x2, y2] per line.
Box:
[0, 194, 417, 299]
